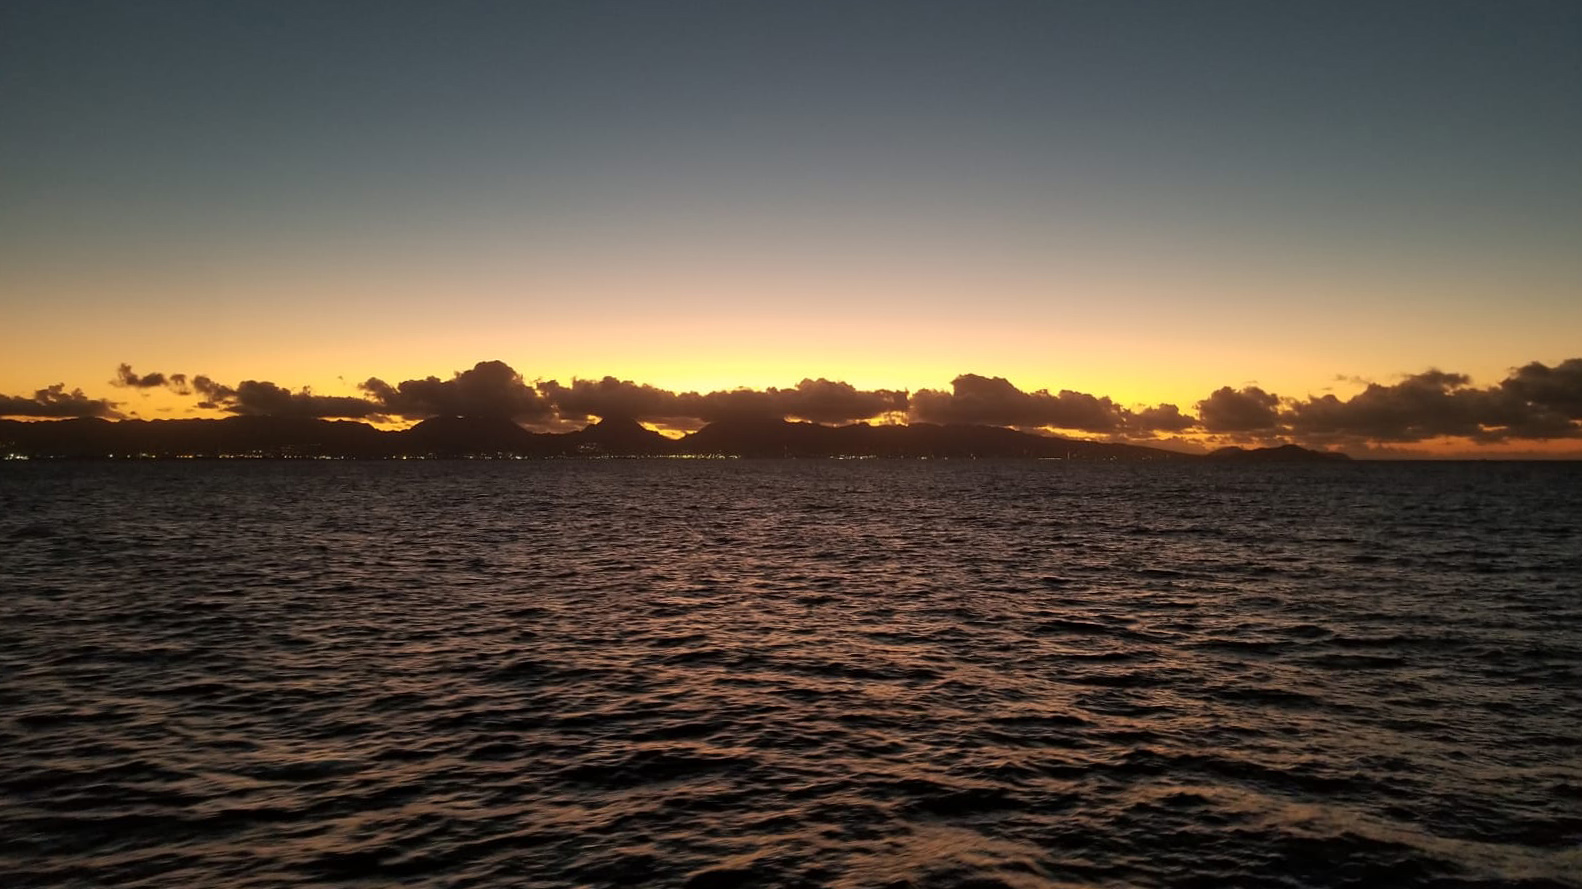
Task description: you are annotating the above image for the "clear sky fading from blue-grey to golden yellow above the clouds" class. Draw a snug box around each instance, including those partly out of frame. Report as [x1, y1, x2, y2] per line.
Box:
[0, 0, 1582, 454]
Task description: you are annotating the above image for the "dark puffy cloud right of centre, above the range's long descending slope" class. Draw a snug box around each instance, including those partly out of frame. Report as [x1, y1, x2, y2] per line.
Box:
[910, 373, 1130, 432]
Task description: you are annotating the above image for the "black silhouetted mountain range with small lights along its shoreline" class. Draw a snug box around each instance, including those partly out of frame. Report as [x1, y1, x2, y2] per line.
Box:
[0, 416, 1346, 462]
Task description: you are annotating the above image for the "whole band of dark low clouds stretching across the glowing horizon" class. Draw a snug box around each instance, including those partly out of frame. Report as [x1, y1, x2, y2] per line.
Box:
[0, 357, 1582, 451]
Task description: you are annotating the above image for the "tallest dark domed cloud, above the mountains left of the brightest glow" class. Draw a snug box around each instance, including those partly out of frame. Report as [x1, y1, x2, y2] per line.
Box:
[359, 361, 555, 424]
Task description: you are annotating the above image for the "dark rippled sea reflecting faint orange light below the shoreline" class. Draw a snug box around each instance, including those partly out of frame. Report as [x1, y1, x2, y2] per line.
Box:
[0, 460, 1582, 889]
